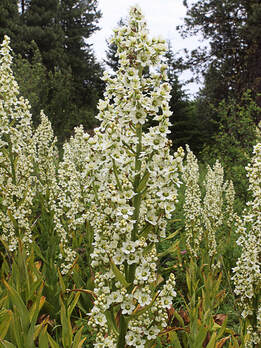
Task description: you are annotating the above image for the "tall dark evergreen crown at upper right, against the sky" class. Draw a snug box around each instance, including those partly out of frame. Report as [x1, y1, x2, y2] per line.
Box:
[180, 0, 261, 106]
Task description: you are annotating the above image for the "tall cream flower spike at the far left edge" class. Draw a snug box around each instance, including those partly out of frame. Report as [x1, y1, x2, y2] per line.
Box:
[0, 36, 36, 251]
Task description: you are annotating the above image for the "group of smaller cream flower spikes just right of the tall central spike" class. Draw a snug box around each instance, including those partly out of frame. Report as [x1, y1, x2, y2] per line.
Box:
[182, 146, 236, 257]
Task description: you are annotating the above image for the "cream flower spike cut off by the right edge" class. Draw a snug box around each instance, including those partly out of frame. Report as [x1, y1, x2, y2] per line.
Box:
[232, 143, 261, 347]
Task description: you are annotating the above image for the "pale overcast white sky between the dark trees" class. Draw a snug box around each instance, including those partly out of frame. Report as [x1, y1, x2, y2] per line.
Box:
[89, 0, 200, 96]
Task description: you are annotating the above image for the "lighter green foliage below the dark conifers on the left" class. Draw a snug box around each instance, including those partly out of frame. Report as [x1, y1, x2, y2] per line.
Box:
[14, 44, 97, 145]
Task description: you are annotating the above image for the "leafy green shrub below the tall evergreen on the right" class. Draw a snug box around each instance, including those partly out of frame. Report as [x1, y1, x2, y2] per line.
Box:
[202, 91, 261, 201]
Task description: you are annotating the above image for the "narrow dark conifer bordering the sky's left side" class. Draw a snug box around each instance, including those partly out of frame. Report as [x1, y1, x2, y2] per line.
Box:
[60, 0, 101, 107]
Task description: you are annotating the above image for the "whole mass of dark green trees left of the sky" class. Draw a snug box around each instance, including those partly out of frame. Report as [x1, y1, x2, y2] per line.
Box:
[0, 0, 104, 143]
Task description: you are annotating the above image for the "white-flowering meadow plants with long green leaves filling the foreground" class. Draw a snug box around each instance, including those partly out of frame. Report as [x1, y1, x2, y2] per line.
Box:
[0, 7, 261, 348]
